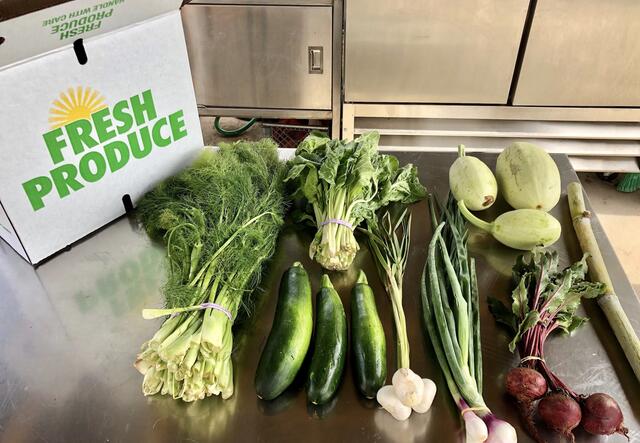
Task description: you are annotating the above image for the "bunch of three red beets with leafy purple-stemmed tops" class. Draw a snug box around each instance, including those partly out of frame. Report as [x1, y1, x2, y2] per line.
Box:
[489, 248, 628, 441]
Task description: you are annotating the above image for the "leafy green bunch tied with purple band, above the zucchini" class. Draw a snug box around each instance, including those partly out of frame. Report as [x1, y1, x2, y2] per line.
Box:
[285, 132, 426, 270]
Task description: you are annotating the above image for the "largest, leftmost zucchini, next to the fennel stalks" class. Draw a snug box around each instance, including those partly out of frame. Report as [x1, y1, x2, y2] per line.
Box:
[255, 262, 313, 400]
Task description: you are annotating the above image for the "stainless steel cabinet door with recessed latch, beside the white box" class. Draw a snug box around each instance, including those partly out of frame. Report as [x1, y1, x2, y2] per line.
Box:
[182, 3, 332, 110]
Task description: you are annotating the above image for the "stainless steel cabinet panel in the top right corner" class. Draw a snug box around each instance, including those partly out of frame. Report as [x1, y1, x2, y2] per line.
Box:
[514, 0, 640, 106]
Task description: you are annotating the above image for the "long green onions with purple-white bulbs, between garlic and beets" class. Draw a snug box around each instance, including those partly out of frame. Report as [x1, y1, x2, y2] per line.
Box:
[421, 195, 517, 443]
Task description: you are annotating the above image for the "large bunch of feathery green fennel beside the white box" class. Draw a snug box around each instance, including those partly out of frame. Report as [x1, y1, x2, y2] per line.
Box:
[135, 139, 286, 401]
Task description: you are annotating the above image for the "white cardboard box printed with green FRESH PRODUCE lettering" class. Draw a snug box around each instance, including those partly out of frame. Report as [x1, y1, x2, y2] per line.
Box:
[0, 0, 203, 264]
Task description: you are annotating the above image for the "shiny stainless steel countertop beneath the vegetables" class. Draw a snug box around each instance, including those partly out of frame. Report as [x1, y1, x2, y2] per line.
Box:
[0, 153, 640, 443]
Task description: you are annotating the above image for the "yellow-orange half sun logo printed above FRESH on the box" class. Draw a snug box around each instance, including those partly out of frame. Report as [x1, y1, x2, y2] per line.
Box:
[49, 86, 107, 129]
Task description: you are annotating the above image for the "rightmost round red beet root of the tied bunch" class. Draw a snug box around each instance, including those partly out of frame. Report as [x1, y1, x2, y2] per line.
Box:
[582, 393, 629, 438]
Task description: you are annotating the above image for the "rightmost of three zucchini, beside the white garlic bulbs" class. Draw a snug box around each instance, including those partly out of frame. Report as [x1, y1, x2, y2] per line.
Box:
[351, 271, 387, 398]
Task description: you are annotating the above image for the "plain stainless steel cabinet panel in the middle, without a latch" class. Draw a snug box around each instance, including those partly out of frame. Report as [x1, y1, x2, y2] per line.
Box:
[345, 0, 529, 104]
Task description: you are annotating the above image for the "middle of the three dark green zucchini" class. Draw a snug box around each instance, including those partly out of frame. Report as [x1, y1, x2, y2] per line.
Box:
[307, 274, 347, 405]
